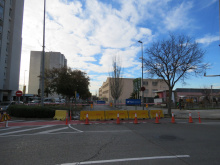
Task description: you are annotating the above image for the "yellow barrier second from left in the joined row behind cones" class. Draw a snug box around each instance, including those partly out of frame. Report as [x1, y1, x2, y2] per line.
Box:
[105, 110, 128, 120]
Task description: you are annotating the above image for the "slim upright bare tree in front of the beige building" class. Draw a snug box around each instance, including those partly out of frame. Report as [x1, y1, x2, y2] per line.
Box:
[109, 57, 123, 106]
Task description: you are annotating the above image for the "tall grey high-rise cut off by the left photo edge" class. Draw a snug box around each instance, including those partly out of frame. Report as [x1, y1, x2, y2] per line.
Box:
[0, 0, 24, 101]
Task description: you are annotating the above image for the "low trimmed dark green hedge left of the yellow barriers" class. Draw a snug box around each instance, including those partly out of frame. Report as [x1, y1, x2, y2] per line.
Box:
[8, 105, 55, 118]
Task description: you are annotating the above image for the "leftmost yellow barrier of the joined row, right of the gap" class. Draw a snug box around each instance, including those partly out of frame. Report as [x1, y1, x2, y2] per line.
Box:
[80, 111, 105, 120]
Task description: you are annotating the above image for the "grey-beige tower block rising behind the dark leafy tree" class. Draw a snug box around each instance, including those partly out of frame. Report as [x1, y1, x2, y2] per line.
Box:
[28, 51, 67, 95]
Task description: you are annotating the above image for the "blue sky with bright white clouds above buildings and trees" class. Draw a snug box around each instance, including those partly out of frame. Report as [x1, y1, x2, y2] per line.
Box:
[20, 0, 220, 94]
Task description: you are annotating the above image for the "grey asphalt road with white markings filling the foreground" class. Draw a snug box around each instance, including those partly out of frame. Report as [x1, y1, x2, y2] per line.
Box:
[0, 119, 220, 165]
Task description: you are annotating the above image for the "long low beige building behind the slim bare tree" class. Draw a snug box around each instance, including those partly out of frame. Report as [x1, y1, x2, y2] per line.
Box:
[99, 77, 168, 103]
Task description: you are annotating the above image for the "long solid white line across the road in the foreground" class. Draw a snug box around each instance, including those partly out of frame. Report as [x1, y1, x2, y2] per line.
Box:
[61, 155, 190, 165]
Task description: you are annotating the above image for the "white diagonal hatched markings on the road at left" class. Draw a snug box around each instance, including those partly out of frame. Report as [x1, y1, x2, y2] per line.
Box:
[0, 124, 83, 138]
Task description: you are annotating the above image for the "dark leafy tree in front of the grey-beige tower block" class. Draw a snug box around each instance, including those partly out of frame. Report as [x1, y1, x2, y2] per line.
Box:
[45, 67, 91, 99]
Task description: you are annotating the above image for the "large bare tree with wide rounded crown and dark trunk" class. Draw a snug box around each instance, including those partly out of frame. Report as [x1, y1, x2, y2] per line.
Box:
[144, 34, 208, 115]
